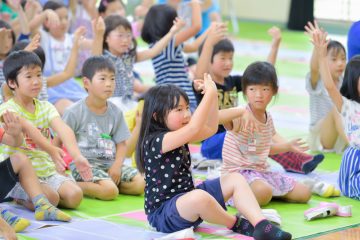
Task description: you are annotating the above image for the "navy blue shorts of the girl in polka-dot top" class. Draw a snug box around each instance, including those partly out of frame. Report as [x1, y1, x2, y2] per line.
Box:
[148, 178, 226, 233]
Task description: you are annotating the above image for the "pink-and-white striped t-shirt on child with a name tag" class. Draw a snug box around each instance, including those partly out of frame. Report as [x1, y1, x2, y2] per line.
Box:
[222, 108, 275, 174]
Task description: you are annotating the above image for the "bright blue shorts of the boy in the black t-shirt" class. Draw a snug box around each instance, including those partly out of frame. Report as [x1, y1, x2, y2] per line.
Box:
[201, 132, 226, 159]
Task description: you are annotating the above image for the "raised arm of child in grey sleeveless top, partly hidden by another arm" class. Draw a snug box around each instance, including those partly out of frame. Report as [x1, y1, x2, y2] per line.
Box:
[305, 21, 321, 89]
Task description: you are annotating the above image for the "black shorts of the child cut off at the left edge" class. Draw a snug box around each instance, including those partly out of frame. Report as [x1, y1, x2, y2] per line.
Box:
[0, 158, 19, 202]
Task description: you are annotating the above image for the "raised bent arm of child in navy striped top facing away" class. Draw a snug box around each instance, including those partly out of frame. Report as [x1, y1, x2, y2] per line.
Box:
[175, 0, 202, 46]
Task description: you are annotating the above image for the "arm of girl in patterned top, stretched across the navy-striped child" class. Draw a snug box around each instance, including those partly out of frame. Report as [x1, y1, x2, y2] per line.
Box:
[136, 18, 185, 62]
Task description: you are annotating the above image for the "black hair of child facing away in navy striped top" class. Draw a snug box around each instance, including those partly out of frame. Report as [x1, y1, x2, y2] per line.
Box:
[141, 4, 177, 44]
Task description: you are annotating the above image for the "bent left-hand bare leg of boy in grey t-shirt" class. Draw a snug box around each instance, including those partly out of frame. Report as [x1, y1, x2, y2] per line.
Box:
[77, 179, 119, 201]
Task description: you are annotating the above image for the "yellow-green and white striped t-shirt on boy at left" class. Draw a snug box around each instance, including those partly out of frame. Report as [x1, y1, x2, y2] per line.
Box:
[0, 98, 60, 177]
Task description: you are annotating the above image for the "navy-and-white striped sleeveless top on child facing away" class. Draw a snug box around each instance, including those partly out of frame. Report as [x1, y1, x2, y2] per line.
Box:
[151, 38, 197, 110]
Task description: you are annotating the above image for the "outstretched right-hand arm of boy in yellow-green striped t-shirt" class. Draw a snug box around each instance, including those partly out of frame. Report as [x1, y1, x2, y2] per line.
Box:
[50, 117, 92, 181]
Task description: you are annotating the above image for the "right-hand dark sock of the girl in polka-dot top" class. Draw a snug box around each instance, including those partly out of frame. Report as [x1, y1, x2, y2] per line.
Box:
[253, 219, 291, 240]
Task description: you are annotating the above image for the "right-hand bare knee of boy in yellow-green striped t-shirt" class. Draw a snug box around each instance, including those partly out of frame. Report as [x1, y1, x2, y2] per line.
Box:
[58, 181, 83, 209]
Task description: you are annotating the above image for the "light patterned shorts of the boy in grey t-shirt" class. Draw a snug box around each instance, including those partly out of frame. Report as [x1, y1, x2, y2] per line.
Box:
[70, 164, 138, 182]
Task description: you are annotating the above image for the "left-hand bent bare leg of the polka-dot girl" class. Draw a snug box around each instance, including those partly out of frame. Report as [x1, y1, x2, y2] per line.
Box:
[176, 189, 236, 228]
